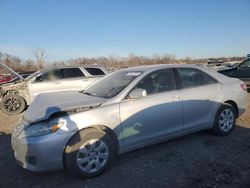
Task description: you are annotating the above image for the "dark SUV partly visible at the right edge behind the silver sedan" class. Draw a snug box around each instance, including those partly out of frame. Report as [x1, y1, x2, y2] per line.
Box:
[218, 58, 250, 91]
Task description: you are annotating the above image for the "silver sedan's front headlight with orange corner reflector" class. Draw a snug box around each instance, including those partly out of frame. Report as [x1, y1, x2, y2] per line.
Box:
[20, 119, 66, 137]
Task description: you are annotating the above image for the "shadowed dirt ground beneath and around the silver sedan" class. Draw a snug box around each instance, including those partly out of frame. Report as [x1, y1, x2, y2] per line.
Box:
[0, 95, 250, 187]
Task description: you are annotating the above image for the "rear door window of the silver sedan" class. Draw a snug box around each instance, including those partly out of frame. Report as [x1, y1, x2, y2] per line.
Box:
[177, 68, 206, 88]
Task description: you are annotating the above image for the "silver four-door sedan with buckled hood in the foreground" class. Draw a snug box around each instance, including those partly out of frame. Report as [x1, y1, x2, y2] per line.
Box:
[12, 65, 247, 178]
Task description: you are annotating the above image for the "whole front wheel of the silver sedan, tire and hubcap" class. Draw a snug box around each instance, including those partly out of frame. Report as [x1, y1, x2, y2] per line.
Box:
[64, 128, 115, 178]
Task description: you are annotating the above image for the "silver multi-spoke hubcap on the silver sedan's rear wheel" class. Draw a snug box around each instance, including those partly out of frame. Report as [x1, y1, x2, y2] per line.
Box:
[219, 109, 234, 131]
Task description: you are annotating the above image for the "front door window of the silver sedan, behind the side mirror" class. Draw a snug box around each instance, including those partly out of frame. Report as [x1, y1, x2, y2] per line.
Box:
[136, 69, 175, 95]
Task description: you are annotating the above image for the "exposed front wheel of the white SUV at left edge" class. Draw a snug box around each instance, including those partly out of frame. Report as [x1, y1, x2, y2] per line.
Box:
[1, 94, 26, 115]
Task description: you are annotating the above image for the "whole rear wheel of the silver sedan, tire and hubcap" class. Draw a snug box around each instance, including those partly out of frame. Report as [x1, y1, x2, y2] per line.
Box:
[213, 104, 236, 136]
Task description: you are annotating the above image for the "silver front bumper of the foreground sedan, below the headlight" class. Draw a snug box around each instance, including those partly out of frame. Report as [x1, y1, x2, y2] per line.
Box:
[11, 121, 72, 172]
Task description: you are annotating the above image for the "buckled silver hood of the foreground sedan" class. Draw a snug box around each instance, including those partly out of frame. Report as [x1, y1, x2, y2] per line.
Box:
[24, 91, 105, 123]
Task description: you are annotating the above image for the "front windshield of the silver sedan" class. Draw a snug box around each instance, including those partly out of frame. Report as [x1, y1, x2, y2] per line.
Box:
[83, 70, 141, 98]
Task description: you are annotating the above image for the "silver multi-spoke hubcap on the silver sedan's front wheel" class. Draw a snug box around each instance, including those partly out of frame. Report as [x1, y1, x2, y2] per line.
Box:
[76, 139, 109, 173]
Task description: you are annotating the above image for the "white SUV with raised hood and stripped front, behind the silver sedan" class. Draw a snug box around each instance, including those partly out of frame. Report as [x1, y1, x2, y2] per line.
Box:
[0, 65, 108, 114]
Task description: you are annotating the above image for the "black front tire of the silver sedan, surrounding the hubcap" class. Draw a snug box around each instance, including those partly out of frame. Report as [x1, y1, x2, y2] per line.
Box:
[64, 128, 116, 179]
